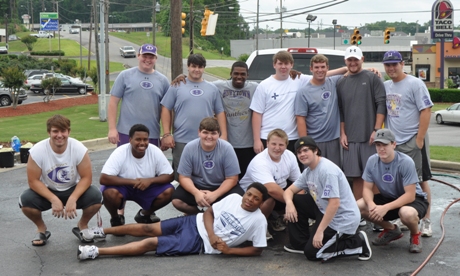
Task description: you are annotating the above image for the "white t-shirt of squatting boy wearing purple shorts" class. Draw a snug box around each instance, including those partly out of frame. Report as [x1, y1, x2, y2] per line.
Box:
[101, 144, 173, 179]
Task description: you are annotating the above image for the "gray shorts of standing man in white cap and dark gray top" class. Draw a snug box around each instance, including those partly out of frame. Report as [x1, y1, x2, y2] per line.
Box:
[343, 142, 377, 177]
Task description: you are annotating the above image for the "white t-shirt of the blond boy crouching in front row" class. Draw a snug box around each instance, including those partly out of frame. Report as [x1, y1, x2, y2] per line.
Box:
[240, 149, 300, 191]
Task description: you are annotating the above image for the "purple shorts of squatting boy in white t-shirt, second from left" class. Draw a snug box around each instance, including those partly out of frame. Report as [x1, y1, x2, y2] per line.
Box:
[101, 183, 174, 210]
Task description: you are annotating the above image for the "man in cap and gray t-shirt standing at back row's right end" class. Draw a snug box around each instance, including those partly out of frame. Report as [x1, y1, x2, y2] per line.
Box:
[383, 51, 433, 237]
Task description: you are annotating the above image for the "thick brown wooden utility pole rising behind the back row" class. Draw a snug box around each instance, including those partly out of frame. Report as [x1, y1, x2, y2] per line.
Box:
[170, 0, 184, 79]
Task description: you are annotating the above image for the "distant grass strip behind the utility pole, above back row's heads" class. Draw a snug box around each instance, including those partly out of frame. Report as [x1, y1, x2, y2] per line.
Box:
[109, 32, 235, 60]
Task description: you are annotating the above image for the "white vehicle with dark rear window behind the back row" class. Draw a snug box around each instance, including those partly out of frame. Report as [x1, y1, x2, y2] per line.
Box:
[246, 47, 345, 82]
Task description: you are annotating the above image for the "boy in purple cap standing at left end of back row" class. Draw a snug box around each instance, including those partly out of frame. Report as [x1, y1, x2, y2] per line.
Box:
[107, 44, 169, 226]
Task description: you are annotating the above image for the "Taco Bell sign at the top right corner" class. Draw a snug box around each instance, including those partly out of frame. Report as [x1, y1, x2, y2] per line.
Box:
[431, 0, 454, 38]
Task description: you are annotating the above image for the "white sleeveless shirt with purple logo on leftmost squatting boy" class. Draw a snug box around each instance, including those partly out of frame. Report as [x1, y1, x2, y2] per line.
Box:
[29, 137, 88, 191]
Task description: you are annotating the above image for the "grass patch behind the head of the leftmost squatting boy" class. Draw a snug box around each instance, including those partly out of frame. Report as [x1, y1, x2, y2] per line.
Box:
[0, 104, 108, 143]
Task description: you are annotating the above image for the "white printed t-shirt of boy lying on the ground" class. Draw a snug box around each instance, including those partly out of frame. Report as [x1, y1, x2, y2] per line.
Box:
[196, 194, 267, 254]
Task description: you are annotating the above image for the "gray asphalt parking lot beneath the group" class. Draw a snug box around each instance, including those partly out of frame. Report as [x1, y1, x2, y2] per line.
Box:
[0, 148, 460, 276]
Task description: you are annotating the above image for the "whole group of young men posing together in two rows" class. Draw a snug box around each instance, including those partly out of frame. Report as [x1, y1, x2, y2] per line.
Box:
[20, 44, 432, 260]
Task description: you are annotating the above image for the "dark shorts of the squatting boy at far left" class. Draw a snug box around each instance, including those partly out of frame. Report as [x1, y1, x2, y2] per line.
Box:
[19, 185, 102, 212]
